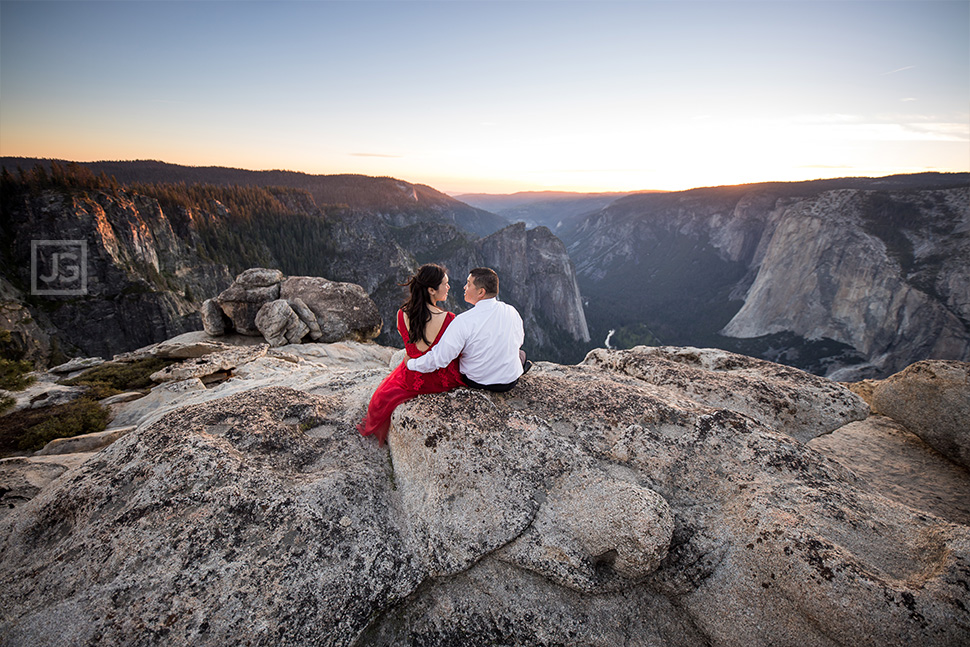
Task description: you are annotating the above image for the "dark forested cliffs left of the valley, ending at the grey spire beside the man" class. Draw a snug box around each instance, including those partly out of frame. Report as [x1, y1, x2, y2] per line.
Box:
[0, 163, 589, 366]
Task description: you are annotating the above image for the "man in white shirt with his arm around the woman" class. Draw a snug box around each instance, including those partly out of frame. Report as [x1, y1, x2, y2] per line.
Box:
[408, 267, 532, 391]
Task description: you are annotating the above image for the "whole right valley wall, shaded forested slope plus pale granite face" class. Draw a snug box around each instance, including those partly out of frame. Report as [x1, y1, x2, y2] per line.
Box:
[563, 180, 970, 378]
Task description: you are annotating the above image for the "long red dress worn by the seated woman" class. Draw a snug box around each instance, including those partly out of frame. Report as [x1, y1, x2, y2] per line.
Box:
[357, 310, 465, 446]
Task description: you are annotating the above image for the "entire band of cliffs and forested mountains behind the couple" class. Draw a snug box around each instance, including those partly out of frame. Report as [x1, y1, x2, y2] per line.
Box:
[0, 158, 970, 379]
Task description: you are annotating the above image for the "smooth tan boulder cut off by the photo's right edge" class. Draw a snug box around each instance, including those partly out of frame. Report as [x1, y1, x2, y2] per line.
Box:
[871, 360, 970, 469]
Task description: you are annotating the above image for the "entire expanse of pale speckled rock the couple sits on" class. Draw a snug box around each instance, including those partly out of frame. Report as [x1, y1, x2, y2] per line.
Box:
[0, 333, 970, 647]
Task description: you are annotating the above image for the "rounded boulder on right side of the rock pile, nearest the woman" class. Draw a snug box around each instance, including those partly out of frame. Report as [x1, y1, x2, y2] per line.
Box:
[280, 276, 382, 342]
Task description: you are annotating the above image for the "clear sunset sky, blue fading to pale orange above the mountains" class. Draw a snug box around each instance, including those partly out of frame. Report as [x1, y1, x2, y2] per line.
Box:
[0, 0, 970, 194]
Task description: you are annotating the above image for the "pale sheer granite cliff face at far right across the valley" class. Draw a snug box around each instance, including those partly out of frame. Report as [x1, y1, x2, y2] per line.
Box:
[724, 188, 970, 375]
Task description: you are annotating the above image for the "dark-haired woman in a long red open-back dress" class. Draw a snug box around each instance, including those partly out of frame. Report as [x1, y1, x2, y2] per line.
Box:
[357, 263, 464, 446]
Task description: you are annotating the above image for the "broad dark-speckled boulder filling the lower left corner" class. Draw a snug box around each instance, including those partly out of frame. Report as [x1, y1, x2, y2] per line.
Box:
[0, 388, 423, 647]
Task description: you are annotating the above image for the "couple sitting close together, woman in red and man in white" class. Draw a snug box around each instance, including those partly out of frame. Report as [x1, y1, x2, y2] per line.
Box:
[357, 263, 532, 445]
